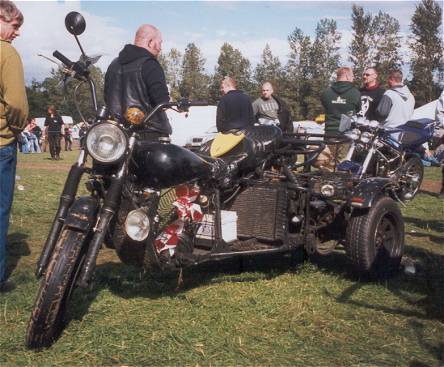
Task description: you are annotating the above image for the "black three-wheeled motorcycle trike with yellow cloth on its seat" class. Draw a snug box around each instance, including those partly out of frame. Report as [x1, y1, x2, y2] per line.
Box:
[26, 13, 404, 349]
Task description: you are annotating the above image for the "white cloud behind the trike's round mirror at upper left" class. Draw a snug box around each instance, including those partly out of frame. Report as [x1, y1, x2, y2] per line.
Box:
[14, 1, 131, 83]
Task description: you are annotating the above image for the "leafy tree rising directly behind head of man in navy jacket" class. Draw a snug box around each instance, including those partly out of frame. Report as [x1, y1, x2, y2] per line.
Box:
[210, 43, 253, 103]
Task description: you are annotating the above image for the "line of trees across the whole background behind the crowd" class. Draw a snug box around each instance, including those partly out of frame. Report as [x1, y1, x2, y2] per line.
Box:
[27, 0, 444, 121]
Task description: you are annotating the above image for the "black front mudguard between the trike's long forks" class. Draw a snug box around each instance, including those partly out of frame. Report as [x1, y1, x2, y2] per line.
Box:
[65, 196, 99, 233]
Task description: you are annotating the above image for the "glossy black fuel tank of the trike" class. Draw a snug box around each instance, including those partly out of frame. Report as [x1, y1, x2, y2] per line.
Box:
[130, 142, 211, 189]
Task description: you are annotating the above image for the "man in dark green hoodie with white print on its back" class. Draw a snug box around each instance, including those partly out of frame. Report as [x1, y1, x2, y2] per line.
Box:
[321, 67, 361, 133]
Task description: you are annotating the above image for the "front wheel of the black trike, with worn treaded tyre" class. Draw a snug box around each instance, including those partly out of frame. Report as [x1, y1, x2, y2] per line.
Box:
[26, 228, 86, 349]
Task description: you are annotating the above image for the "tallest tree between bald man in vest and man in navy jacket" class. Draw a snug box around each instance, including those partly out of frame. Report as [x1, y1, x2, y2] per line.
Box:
[179, 43, 209, 99]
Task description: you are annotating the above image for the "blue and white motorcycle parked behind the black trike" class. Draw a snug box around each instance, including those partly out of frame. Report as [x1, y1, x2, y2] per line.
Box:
[337, 115, 435, 202]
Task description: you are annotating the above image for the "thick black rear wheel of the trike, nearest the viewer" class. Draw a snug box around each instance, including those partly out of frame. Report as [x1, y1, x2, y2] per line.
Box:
[346, 197, 404, 278]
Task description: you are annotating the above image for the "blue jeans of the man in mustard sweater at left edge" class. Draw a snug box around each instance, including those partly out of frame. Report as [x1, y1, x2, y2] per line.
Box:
[0, 142, 17, 282]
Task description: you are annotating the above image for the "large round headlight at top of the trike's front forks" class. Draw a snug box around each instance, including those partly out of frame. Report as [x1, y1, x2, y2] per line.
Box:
[85, 122, 128, 163]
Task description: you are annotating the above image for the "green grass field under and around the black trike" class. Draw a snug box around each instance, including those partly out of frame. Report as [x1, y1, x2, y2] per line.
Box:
[0, 152, 444, 367]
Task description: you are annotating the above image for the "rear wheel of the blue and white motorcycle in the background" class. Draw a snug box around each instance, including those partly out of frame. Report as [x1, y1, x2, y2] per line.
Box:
[399, 157, 424, 201]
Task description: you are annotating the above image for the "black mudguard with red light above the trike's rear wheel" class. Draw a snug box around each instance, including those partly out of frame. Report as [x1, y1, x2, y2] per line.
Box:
[351, 177, 391, 208]
